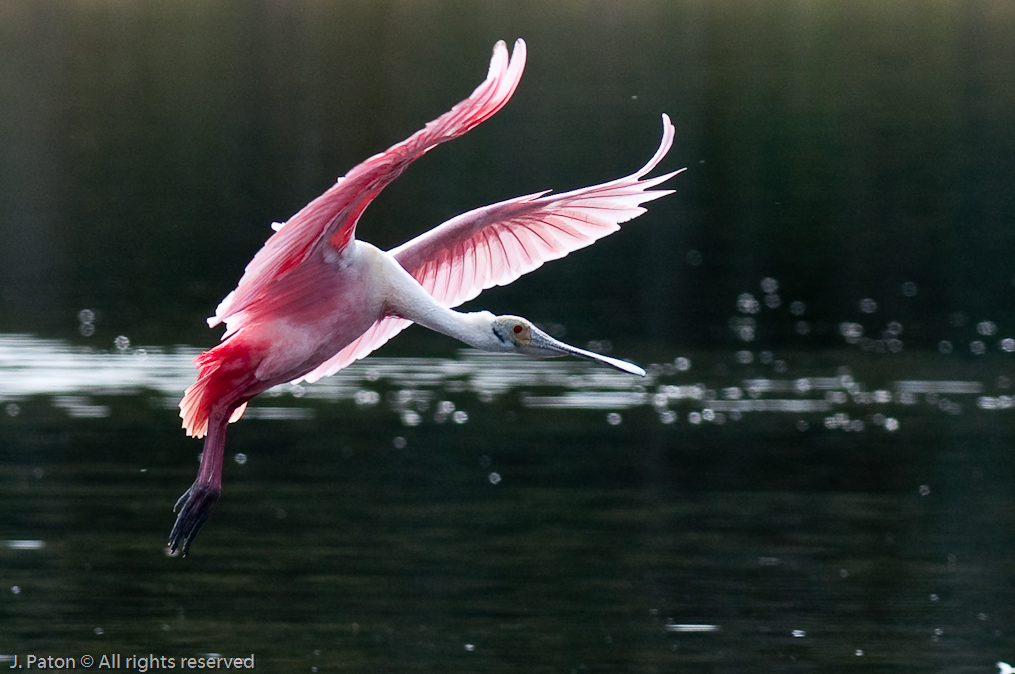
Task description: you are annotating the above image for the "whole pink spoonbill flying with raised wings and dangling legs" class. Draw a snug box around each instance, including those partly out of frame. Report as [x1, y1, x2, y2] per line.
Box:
[168, 39, 683, 556]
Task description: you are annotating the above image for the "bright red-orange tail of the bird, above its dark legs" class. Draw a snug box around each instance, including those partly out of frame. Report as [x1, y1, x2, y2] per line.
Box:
[180, 335, 257, 437]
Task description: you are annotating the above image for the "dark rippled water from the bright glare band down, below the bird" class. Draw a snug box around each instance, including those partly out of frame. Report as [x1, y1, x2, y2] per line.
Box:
[0, 335, 1015, 671]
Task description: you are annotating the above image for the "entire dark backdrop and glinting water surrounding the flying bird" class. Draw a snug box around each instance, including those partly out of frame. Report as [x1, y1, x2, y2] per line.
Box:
[0, 1, 1015, 672]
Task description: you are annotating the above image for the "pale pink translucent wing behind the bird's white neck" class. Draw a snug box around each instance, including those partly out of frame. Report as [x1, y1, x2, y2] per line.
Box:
[303, 115, 683, 382]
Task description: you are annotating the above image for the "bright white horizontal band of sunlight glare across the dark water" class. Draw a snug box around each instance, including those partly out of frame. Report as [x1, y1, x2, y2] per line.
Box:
[0, 335, 1015, 430]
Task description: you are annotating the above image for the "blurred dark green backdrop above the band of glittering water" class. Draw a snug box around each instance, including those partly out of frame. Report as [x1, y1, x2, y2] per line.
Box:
[0, 1, 1015, 352]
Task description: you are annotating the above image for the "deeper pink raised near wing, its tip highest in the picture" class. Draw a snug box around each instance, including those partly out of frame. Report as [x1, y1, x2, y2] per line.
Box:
[208, 40, 526, 339]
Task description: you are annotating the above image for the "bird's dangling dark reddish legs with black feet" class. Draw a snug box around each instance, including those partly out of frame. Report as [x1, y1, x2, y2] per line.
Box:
[168, 412, 229, 557]
